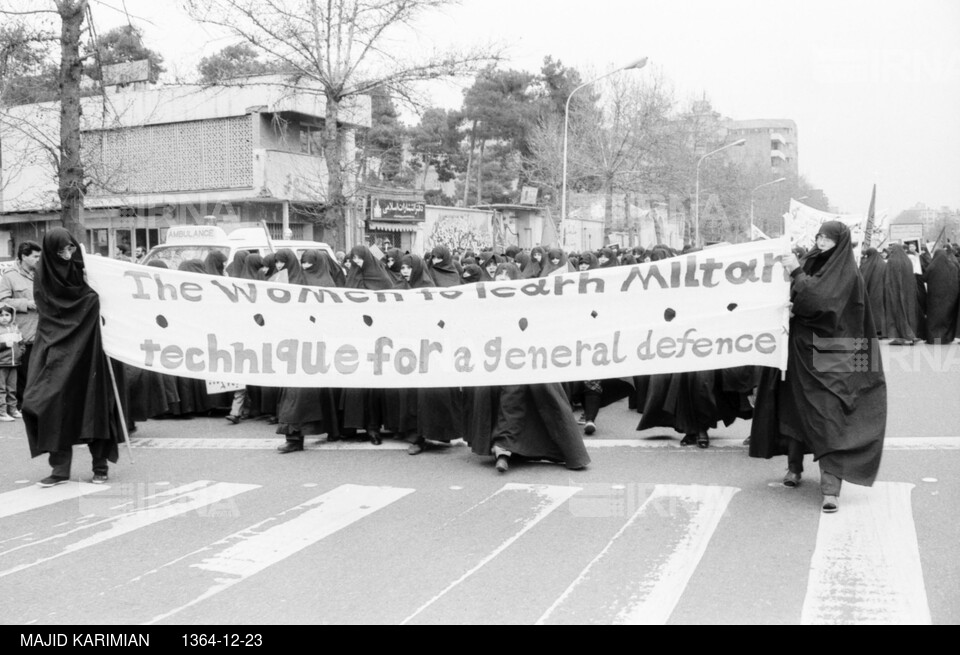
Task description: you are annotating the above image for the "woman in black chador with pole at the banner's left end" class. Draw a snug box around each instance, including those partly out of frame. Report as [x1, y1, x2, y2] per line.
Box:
[23, 227, 123, 487]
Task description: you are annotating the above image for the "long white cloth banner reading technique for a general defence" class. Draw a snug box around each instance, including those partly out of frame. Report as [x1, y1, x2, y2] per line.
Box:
[86, 238, 789, 388]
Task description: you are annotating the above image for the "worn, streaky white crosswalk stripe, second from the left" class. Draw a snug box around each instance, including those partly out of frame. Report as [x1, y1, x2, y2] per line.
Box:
[0, 480, 259, 578]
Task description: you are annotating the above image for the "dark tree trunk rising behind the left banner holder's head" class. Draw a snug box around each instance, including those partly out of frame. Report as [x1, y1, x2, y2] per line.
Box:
[57, 0, 87, 243]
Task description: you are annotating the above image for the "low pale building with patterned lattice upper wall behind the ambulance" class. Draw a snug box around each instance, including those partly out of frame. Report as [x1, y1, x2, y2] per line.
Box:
[0, 75, 371, 256]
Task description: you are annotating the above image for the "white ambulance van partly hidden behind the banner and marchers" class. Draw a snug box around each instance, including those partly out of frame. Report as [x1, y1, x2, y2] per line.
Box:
[141, 225, 336, 270]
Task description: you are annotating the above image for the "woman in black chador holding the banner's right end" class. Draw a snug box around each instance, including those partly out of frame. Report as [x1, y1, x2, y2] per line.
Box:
[750, 221, 887, 513]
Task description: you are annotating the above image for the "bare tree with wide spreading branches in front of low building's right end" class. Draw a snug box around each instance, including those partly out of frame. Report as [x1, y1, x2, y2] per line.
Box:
[186, 0, 498, 246]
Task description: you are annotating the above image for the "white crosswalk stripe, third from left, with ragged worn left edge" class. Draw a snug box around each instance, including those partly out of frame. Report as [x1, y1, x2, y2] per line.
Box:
[145, 484, 414, 625]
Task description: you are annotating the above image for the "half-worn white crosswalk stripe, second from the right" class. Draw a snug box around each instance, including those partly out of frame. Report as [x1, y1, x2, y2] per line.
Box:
[537, 485, 740, 625]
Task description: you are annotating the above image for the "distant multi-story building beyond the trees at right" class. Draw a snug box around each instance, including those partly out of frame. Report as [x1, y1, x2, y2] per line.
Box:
[723, 119, 798, 179]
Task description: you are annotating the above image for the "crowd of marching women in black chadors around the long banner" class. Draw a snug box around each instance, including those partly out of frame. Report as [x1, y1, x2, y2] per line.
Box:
[0, 223, 960, 512]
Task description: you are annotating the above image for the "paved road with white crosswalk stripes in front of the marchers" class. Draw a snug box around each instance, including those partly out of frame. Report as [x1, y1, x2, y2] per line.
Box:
[0, 346, 960, 625]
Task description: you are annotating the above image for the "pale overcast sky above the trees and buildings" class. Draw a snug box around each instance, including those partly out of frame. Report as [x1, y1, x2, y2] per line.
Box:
[93, 0, 960, 216]
